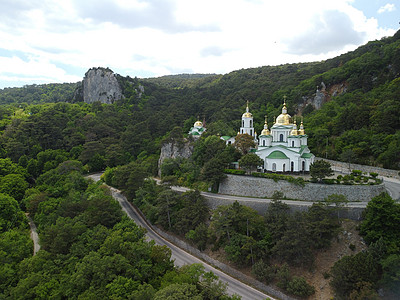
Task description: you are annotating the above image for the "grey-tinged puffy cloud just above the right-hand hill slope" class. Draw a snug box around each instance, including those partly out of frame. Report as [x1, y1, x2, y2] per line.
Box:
[287, 10, 365, 55]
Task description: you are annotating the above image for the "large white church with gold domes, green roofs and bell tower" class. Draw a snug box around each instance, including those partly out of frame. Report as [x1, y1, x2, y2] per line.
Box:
[222, 99, 315, 173]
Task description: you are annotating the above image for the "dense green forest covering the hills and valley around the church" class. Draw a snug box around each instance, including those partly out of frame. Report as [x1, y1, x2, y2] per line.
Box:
[0, 31, 400, 299]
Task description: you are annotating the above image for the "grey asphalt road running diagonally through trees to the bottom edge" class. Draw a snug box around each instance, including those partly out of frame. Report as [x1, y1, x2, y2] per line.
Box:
[88, 174, 274, 300]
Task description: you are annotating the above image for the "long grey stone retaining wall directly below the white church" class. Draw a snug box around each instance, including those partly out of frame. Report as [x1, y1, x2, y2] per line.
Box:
[218, 175, 386, 202]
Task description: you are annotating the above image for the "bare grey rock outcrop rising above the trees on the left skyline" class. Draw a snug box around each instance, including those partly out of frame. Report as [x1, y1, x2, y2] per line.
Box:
[81, 68, 124, 104]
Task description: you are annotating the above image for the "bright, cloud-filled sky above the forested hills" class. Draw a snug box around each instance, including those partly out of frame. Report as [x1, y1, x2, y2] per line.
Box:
[0, 0, 400, 89]
